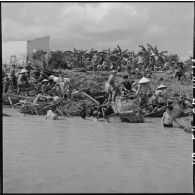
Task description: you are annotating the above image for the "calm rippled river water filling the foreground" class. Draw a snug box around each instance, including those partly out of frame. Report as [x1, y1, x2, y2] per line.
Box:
[3, 109, 193, 193]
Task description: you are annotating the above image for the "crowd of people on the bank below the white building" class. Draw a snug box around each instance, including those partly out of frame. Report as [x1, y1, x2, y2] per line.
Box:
[2, 61, 71, 98]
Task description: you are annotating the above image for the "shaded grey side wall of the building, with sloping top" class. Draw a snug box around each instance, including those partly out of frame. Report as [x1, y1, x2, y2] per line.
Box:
[27, 36, 49, 60]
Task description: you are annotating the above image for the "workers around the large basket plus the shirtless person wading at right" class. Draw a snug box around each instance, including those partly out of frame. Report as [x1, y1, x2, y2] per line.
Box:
[105, 71, 191, 132]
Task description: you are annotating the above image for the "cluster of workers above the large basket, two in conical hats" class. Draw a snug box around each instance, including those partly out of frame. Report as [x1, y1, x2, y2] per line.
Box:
[105, 71, 167, 108]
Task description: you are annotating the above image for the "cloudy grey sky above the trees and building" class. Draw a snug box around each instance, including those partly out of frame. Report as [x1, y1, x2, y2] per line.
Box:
[1, 2, 194, 58]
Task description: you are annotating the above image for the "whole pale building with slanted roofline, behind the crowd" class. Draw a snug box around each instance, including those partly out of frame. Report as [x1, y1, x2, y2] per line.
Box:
[2, 36, 49, 66]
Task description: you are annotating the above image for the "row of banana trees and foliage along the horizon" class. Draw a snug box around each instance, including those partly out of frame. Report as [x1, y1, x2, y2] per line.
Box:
[30, 44, 184, 70]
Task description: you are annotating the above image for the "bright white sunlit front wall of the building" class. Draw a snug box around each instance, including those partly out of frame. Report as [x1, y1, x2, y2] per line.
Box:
[2, 41, 27, 66]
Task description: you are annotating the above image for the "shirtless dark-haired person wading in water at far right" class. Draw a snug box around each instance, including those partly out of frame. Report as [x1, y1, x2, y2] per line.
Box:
[161, 105, 185, 128]
